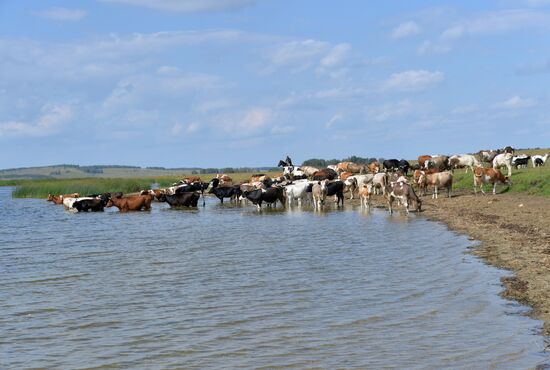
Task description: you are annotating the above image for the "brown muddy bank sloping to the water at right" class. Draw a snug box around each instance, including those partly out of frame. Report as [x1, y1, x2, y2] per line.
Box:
[362, 194, 550, 335]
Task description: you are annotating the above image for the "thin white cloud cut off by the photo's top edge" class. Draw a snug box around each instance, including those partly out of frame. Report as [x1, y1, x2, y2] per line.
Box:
[102, 0, 255, 13]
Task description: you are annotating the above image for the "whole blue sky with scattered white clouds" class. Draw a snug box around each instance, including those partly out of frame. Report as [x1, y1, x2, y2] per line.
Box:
[0, 0, 550, 168]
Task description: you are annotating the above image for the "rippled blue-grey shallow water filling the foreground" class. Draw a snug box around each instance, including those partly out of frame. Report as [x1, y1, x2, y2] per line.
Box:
[0, 188, 548, 369]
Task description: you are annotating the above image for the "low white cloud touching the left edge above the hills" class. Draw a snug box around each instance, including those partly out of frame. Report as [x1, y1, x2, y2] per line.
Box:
[0, 104, 73, 137]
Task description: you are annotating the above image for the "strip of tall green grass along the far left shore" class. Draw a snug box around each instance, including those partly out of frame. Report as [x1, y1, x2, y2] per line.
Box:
[0, 172, 284, 198]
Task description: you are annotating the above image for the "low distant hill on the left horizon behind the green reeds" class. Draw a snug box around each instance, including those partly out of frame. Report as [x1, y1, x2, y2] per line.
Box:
[0, 164, 273, 180]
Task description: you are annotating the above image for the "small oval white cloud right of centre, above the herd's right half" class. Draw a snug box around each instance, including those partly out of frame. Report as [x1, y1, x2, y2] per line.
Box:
[383, 70, 445, 92]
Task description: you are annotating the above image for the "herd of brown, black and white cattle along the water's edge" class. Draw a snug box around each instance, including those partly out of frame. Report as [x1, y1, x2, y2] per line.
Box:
[48, 147, 549, 213]
